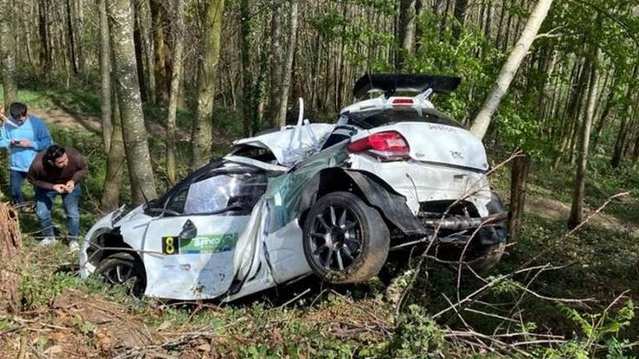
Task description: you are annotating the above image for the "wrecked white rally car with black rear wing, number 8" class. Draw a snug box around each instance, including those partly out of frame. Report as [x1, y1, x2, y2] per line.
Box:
[80, 74, 507, 301]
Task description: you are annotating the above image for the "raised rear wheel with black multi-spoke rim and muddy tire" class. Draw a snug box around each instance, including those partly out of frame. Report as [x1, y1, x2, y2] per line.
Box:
[303, 192, 390, 283]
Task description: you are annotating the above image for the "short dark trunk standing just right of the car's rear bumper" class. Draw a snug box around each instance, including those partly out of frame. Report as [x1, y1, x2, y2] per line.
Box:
[508, 154, 531, 242]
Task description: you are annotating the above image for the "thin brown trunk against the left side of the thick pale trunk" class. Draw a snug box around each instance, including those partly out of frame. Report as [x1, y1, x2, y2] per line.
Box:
[100, 96, 127, 213]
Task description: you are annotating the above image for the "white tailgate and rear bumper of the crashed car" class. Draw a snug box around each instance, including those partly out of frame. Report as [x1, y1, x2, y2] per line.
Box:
[351, 122, 491, 216]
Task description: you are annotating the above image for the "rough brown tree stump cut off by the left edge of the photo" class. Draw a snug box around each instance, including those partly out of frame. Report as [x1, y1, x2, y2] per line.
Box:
[0, 202, 22, 313]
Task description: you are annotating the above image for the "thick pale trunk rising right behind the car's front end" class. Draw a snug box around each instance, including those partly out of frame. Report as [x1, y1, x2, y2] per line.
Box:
[107, 0, 157, 204]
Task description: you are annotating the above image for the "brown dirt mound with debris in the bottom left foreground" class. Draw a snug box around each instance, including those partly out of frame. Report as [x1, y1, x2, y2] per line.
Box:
[0, 289, 225, 359]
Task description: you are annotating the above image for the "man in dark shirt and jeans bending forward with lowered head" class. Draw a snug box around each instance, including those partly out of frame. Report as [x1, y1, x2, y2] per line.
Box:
[27, 145, 88, 252]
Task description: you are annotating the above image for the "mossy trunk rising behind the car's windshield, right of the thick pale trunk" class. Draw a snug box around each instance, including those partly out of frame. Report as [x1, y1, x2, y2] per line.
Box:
[191, 0, 225, 169]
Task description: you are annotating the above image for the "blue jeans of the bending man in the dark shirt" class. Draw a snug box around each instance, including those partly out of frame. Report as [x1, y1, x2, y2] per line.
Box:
[35, 183, 82, 238]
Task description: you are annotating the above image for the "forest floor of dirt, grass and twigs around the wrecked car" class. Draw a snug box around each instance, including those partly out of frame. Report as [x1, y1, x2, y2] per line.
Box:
[0, 102, 639, 358]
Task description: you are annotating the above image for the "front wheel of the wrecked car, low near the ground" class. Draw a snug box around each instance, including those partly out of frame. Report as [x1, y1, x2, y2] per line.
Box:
[95, 252, 146, 297]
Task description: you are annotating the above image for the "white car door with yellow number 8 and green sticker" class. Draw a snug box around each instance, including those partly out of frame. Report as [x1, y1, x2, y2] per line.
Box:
[143, 174, 254, 300]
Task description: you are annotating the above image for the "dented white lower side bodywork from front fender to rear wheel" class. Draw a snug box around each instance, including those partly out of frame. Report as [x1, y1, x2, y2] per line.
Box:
[80, 193, 310, 301]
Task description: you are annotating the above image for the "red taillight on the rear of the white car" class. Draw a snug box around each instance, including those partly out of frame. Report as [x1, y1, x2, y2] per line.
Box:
[348, 131, 410, 160]
